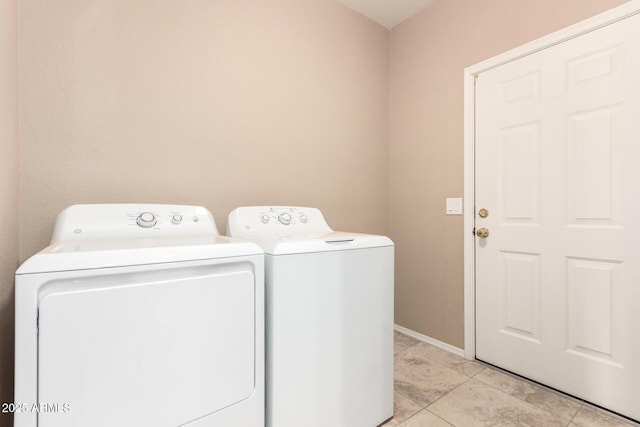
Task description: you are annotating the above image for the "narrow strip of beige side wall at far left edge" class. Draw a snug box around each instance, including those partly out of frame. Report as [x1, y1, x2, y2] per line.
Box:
[0, 0, 18, 426]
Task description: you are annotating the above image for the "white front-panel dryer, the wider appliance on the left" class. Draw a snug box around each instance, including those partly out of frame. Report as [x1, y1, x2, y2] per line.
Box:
[15, 204, 264, 427]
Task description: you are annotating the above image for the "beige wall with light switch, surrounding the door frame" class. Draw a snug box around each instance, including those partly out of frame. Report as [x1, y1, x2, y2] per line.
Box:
[389, 0, 624, 348]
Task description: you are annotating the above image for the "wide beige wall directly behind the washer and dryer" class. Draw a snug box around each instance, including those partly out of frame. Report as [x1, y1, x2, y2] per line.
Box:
[20, 0, 388, 260]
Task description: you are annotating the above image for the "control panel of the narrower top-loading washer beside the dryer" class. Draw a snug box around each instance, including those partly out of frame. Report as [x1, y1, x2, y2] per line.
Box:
[227, 206, 332, 235]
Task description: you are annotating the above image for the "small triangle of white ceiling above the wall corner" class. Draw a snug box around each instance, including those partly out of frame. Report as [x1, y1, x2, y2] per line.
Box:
[337, 0, 436, 29]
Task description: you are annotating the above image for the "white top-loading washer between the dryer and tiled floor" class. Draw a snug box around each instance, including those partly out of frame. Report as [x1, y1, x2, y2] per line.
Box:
[227, 206, 394, 427]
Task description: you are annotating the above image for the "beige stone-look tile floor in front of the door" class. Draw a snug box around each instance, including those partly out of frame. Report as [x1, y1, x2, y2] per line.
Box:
[383, 332, 639, 427]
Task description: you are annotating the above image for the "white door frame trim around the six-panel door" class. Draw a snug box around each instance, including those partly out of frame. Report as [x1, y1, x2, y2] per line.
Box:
[464, 0, 640, 359]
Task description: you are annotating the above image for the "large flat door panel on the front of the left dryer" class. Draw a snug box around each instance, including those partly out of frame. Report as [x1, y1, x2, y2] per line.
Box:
[37, 263, 256, 427]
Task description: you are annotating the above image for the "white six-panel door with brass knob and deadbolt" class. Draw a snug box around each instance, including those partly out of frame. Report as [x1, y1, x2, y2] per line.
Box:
[475, 9, 640, 420]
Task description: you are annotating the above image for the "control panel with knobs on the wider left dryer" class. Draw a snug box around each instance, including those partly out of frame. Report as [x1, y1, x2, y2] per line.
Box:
[51, 203, 219, 243]
